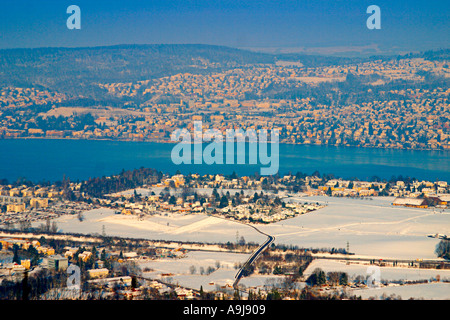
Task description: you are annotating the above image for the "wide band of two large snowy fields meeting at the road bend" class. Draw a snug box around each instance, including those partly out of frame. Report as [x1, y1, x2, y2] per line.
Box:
[41, 195, 450, 260]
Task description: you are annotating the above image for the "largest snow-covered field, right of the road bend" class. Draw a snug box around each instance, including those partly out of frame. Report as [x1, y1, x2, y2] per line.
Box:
[260, 196, 450, 259]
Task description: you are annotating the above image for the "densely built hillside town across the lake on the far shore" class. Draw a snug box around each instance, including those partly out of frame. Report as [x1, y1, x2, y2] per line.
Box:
[0, 55, 450, 149]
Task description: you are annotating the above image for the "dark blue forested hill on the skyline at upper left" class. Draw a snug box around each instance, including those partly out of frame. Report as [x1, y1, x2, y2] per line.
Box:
[0, 44, 358, 98]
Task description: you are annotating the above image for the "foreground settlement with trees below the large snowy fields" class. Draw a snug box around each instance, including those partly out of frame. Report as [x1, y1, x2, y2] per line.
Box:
[0, 228, 450, 300]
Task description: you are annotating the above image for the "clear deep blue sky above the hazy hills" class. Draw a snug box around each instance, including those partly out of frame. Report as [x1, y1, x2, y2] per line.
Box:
[0, 0, 450, 51]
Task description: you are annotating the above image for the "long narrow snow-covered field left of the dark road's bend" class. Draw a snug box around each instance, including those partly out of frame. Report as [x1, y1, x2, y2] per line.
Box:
[46, 209, 266, 243]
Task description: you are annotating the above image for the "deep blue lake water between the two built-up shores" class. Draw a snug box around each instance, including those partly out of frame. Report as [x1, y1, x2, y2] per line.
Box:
[0, 139, 450, 181]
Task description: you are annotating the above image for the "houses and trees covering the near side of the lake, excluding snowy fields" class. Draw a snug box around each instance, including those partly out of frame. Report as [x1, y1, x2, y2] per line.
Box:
[0, 169, 450, 300]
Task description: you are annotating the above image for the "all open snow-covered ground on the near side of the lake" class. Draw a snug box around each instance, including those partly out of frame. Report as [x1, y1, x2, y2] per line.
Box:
[33, 195, 450, 299]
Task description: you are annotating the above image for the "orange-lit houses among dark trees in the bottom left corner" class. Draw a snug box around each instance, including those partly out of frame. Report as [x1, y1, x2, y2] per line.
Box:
[0, 236, 205, 300]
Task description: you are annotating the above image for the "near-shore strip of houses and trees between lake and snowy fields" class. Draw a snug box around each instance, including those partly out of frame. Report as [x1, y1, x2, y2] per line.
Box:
[0, 173, 450, 228]
